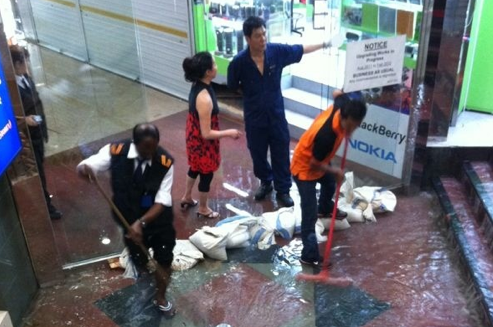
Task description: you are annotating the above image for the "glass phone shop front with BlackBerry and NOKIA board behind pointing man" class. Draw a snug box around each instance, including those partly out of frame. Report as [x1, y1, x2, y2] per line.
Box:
[193, 0, 422, 186]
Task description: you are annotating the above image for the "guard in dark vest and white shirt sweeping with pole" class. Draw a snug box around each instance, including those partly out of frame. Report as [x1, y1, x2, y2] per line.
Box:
[77, 124, 176, 318]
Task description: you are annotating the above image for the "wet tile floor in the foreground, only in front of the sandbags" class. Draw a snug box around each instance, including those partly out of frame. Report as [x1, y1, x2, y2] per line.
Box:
[29, 194, 481, 327]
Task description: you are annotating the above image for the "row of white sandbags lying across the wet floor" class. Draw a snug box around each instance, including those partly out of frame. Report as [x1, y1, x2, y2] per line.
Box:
[184, 172, 397, 261]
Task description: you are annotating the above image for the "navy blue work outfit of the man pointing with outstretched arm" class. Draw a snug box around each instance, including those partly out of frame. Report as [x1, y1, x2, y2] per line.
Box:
[228, 43, 303, 193]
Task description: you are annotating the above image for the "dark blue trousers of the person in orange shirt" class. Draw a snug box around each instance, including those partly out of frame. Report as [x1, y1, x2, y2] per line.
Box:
[293, 174, 336, 261]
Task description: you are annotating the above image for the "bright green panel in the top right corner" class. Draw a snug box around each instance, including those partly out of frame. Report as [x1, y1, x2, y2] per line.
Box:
[459, 0, 493, 113]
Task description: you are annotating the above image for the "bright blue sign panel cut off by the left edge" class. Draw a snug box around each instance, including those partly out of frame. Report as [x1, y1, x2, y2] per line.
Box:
[0, 59, 21, 175]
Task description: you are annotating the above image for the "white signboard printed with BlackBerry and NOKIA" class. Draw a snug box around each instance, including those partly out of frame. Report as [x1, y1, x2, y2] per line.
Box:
[337, 105, 409, 178]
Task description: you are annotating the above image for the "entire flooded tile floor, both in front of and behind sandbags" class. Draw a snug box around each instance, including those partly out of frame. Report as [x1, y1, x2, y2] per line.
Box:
[21, 112, 478, 327]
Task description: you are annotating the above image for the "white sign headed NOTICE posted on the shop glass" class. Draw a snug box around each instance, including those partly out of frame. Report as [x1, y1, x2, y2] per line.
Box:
[344, 35, 406, 92]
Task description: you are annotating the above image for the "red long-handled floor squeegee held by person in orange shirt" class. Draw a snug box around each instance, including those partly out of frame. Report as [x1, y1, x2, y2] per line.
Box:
[296, 138, 353, 287]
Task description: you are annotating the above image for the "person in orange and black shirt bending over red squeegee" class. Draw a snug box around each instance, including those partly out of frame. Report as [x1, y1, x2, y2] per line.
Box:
[291, 91, 367, 266]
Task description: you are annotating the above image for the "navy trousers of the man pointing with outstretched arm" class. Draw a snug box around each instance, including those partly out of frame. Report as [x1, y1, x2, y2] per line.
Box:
[245, 122, 291, 193]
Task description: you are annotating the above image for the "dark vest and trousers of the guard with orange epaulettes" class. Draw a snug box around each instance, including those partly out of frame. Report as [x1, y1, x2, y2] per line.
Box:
[110, 141, 176, 267]
